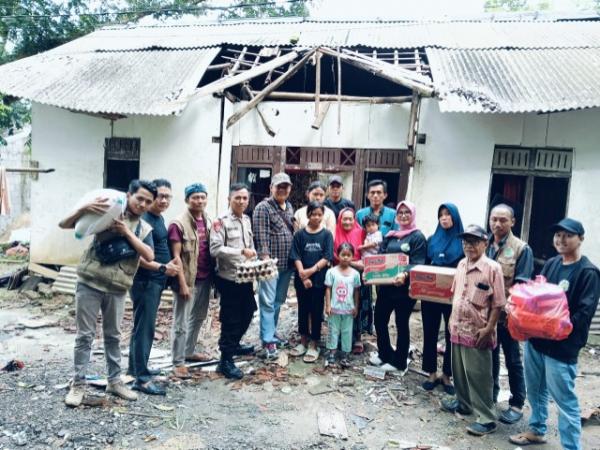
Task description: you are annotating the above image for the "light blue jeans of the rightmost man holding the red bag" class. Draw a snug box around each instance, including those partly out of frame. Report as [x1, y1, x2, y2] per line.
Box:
[525, 342, 581, 450]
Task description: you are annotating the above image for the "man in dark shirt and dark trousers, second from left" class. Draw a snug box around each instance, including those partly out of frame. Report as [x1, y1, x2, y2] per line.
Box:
[127, 179, 181, 395]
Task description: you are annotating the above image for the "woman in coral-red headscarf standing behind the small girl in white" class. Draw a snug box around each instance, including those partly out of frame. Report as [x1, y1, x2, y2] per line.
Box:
[333, 208, 373, 353]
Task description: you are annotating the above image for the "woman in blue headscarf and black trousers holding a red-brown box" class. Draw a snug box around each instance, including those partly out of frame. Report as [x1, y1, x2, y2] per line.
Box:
[421, 203, 464, 395]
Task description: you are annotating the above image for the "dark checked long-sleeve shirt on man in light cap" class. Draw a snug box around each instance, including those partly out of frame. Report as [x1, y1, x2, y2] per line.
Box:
[252, 198, 294, 270]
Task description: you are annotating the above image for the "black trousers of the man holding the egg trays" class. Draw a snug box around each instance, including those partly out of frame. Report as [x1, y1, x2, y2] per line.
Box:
[216, 277, 256, 359]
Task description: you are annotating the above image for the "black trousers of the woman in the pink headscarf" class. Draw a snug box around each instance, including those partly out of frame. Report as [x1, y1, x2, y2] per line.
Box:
[375, 286, 416, 370]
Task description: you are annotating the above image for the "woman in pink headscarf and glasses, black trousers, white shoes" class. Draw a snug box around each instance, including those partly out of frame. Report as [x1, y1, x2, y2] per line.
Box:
[369, 200, 427, 375]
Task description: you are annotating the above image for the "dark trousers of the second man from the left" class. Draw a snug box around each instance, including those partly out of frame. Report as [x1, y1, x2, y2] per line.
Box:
[128, 280, 165, 383]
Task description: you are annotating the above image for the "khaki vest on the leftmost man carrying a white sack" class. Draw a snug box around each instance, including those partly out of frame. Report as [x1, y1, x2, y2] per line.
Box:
[77, 219, 152, 294]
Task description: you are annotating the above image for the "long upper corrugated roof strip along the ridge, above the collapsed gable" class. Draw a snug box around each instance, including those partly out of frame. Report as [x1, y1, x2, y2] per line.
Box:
[55, 20, 600, 52]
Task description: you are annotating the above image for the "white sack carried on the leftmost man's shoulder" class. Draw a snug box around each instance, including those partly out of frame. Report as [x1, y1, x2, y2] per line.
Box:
[75, 189, 127, 239]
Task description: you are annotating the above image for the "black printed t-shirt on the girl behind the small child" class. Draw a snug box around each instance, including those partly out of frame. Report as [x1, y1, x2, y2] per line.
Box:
[290, 228, 333, 287]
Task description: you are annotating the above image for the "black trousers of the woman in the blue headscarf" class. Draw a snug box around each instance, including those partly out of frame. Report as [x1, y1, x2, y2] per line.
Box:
[421, 301, 452, 377]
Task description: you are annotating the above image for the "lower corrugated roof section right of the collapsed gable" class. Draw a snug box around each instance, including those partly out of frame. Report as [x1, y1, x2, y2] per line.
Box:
[426, 48, 600, 113]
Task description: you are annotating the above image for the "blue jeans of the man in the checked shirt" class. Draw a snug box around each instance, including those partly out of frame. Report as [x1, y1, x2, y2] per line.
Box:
[258, 269, 294, 344]
